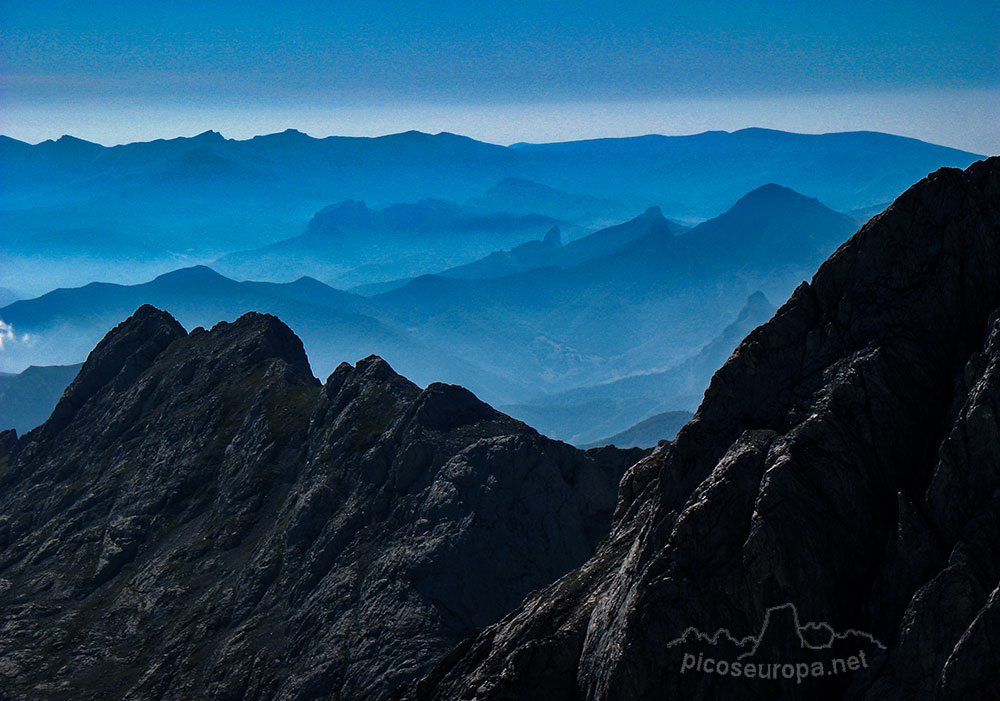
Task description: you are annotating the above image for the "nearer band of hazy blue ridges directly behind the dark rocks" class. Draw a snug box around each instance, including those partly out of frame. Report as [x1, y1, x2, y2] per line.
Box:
[0, 185, 855, 442]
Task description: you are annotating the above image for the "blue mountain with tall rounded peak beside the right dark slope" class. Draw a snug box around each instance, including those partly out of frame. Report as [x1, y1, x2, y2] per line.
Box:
[369, 186, 855, 396]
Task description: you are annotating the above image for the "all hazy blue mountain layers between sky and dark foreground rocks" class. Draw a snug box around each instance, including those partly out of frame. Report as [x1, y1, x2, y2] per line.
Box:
[0, 129, 974, 442]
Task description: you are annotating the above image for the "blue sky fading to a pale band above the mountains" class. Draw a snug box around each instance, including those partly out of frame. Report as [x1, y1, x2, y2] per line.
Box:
[0, 0, 1000, 152]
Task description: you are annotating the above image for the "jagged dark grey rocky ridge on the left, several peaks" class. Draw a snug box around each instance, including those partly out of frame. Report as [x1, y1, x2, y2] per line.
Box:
[0, 306, 645, 699]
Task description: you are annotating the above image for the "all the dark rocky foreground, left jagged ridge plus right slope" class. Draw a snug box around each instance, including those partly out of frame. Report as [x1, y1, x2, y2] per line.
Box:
[0, 157, 1000, 701]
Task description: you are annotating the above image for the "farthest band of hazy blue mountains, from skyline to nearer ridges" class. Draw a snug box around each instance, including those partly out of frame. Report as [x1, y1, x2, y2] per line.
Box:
[0, 129, 975, 296]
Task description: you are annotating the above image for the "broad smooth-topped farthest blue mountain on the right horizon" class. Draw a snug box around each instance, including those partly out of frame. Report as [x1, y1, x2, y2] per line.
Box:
[511, 128, 981, 219]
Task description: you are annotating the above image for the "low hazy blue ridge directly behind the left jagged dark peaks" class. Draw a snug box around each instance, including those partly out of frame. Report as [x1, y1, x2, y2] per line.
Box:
[0, 266, 525, 398]
